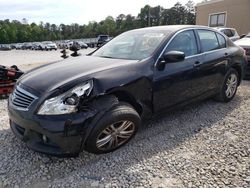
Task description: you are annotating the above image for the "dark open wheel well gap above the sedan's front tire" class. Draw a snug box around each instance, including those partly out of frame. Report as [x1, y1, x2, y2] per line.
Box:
[111, 91, 143, 115]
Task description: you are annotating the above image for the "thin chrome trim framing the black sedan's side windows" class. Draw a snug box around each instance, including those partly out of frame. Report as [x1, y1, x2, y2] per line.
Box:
[154, 27, 228, 67]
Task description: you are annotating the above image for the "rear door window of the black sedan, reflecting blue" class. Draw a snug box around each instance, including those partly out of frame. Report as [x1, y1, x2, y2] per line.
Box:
[197, 30, 220, 52]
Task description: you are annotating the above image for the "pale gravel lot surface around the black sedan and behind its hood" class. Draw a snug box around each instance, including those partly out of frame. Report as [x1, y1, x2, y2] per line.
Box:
[0, 51, 250, 188]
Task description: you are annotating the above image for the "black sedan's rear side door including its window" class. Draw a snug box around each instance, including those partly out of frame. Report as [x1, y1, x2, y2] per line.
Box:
[194, 29, 230, 94]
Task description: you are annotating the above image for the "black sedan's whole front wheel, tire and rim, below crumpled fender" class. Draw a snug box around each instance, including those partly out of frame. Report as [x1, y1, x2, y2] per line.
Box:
[84, 103, 141, 154]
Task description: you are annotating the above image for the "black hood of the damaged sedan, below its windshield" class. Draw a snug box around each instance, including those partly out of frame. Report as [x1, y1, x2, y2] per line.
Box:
[18, 56, 137, 93]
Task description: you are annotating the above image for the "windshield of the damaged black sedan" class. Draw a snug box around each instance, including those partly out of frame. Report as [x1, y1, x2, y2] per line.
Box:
[92, 31, 167, 60]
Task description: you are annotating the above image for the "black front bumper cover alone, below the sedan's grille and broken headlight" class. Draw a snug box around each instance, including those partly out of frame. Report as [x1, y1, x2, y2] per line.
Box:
[9, 104, 94, 157]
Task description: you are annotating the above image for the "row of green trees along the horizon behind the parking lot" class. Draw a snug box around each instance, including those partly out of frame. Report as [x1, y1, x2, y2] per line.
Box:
[0, 0, 195, 44]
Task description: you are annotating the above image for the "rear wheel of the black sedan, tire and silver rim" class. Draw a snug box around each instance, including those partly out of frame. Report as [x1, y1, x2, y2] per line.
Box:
[215, 68, 240, 103]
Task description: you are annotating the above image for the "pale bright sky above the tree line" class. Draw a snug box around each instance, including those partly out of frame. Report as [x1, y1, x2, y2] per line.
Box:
[0, 0, 202, 24]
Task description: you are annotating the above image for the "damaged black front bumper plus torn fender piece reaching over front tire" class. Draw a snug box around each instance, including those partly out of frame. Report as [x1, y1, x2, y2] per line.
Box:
[8, 86, 118, 157]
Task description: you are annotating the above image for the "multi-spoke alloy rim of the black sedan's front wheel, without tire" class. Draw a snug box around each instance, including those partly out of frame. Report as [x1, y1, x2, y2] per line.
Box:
[96, 120, 135, 151]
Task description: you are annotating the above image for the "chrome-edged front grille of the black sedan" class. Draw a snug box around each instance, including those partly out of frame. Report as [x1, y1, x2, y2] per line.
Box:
[10, 86, 38, 111]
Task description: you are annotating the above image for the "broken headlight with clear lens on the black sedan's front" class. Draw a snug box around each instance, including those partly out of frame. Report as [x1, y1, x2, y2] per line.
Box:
[38, 80, 93, 115]
